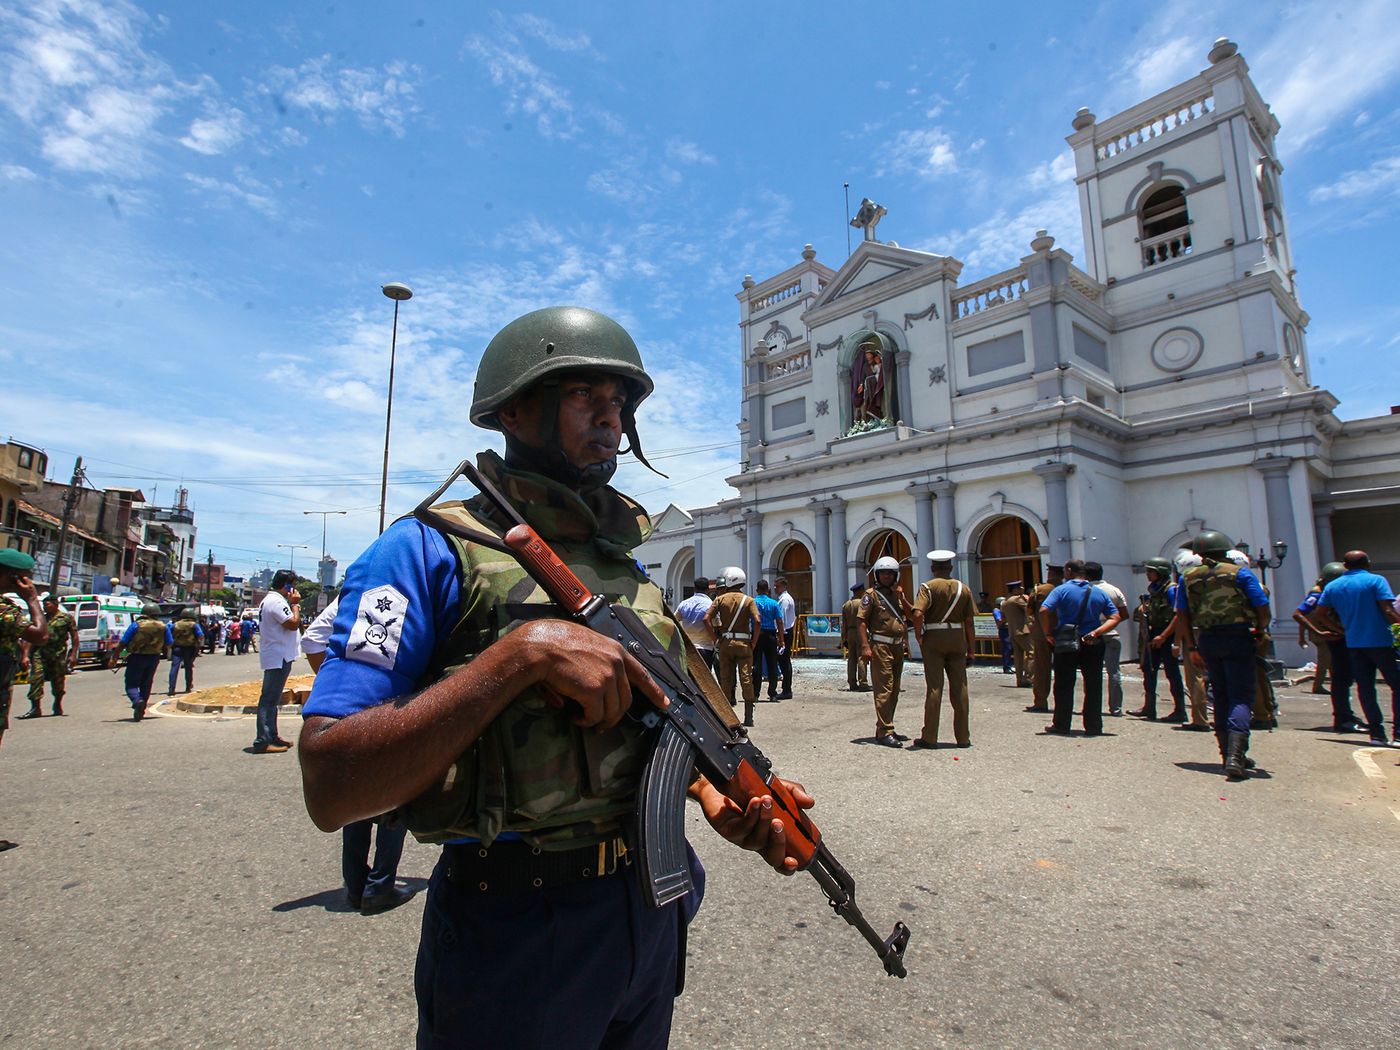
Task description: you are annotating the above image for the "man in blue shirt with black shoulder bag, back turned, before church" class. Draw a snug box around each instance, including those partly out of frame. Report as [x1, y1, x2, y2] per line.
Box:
[1037, 557, 1123, 736]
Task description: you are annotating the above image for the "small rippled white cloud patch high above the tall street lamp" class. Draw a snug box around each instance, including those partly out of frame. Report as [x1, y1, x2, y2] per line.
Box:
[262, 55, 420, 136]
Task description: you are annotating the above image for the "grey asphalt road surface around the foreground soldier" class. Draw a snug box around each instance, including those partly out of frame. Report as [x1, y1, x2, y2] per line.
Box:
[0, 655, 1400, 1050]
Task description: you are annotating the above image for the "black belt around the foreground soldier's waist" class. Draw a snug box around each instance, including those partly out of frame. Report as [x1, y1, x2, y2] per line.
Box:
[442, 839, 631, 893]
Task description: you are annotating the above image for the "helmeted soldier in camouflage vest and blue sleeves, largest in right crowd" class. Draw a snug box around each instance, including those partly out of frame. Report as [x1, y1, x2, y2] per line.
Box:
[1176, 529, 1268, 780]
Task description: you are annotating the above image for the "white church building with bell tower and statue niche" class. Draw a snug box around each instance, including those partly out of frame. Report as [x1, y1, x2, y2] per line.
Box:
[637, 41, 1400, 659]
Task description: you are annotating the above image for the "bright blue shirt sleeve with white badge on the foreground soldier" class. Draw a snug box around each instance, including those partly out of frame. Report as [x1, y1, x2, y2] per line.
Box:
[302, 518, 461, 718]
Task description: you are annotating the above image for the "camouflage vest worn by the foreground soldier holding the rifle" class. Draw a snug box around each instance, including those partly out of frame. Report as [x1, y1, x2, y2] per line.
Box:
[399, 452, 683, 850]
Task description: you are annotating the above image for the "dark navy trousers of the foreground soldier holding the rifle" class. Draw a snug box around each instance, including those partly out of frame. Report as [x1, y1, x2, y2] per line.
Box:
[413, 854, 703, 1050]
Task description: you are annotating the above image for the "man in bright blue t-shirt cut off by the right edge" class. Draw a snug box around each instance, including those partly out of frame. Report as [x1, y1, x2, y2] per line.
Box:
[1317, 550, 1400, 748]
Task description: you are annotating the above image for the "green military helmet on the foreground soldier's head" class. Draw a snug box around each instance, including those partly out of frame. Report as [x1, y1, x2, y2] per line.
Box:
[470, 307, 652, 430]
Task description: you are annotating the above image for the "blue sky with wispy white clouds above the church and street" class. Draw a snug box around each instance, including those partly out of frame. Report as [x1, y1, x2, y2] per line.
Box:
[0, 0, 1400, 570]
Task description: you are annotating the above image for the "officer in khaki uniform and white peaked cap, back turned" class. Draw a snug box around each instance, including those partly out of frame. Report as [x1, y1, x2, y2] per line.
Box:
[910, 550, 976, 748]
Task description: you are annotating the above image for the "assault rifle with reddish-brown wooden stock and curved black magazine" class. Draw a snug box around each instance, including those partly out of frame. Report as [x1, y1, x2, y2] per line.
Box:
[413, 461, 909, 977]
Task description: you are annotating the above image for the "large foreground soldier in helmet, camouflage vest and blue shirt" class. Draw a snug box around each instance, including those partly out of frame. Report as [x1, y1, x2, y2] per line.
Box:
[298, 307, 812, 1050]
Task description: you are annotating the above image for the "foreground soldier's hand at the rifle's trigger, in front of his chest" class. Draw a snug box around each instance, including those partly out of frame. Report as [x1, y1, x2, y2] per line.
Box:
[520, 620, 671, 732]
